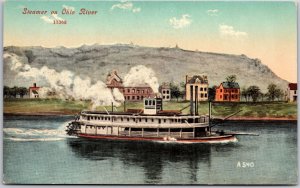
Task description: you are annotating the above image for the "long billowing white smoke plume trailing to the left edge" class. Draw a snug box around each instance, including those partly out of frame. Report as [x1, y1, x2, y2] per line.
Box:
[3, 53, 124, 109]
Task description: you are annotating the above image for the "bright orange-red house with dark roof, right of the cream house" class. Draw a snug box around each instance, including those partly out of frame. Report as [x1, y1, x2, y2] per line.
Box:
[215, 82, 240, 102]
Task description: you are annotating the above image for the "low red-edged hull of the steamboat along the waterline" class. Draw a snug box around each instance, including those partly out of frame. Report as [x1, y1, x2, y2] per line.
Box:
[77, 133, 237, 143]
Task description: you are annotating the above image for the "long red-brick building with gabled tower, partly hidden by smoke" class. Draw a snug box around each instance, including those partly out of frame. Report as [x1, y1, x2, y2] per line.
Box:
[106, 70, 155, 101]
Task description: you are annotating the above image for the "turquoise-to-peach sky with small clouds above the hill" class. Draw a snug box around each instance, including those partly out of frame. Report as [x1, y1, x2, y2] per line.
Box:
[3, 0, 297, 82]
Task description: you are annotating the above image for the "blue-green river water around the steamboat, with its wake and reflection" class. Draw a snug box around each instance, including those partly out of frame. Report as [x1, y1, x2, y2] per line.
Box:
[3, 116, 298, 184]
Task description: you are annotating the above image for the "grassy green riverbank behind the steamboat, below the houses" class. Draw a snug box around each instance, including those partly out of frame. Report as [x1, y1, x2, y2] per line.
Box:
[4, 99, 297, 119]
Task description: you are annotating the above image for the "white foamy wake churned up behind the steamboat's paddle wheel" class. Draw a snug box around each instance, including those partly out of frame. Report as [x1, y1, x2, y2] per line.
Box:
[3, 122, 73, 142]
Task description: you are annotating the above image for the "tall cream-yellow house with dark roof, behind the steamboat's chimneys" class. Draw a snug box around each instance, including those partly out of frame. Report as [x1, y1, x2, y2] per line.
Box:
[185, 75, 208, 101]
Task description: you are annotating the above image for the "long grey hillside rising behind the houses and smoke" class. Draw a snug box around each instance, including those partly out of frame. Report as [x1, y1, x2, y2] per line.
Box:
[3, 44, 288, 92]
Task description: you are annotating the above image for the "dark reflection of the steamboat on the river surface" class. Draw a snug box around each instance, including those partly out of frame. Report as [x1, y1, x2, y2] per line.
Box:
[67, 138, 236, 184]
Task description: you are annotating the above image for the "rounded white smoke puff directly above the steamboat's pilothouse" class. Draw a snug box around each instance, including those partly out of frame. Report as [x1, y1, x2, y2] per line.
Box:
[124, 65, 159, 93]
